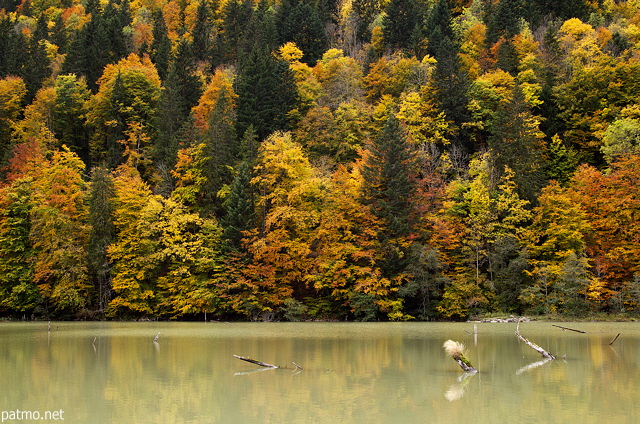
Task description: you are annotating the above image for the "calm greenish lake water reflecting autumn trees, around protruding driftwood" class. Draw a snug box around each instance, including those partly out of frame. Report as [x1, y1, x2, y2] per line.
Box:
[0, 322, 640, 424]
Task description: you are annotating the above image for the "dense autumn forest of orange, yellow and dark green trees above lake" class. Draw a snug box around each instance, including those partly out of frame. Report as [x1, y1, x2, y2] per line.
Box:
[0, 0, 640, 320]
